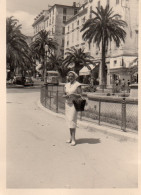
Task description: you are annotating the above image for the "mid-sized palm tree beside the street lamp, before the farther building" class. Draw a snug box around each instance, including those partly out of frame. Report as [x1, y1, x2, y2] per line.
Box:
[31, 30, 58, 82]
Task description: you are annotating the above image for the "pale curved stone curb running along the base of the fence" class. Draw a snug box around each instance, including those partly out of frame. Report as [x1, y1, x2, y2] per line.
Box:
[37, 100, 138, 142]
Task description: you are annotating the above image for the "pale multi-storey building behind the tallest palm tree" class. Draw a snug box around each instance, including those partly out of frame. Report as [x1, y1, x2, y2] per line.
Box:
[65, 0, 139, 85]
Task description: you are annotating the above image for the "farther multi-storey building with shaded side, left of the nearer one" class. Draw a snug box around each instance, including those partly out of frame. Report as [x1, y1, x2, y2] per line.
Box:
[32, 2, 79, 55]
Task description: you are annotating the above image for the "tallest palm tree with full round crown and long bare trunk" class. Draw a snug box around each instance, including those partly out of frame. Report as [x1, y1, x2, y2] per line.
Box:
[81, 5, 127, 86]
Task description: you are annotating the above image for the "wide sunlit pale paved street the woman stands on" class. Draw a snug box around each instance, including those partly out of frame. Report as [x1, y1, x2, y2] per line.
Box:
[7, 88, 138, 189]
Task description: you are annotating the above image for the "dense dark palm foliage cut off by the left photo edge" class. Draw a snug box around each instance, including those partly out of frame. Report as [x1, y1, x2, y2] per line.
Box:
[6, 17, 31, 78]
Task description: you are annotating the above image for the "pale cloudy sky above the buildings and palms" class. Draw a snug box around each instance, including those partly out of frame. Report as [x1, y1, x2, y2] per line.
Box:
[6, 0, 82, 36]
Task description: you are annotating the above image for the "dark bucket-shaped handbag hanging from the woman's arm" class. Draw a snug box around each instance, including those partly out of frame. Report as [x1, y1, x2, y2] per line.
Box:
[73, 97, 86, 112]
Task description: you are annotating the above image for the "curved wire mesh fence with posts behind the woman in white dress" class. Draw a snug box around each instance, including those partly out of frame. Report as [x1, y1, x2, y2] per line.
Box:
[40, 85, 138, 131]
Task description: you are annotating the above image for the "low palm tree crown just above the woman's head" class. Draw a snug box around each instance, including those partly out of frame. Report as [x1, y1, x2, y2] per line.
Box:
[63, 47, 94, 74]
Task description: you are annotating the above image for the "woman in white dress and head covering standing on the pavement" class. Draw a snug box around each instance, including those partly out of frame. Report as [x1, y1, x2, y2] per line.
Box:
[63, 71, 82, 146]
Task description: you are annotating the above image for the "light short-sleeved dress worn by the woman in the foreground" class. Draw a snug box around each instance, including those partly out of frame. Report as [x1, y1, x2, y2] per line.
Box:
[65, 81, 81, 128]
